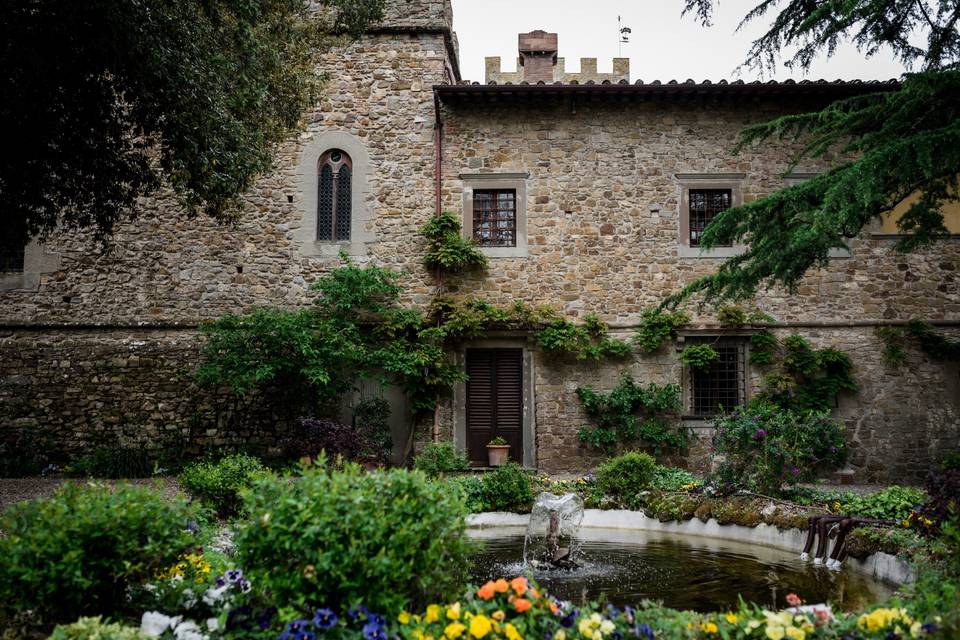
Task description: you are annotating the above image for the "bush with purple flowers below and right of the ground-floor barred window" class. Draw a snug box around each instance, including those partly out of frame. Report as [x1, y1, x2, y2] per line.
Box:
[713, 402, 845, 495]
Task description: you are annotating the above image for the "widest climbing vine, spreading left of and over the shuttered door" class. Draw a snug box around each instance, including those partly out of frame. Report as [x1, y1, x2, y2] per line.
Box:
[196, 255, 630, 413]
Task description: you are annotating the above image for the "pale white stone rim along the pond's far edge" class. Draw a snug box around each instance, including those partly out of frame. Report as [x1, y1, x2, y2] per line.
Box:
[467, 509, 914, 585]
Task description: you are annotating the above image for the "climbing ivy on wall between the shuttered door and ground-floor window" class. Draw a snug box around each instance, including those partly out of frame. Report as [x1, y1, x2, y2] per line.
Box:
[577, 373, 687, 455]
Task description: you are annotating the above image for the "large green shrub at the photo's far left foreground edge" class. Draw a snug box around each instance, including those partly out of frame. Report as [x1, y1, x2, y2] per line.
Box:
[0, 484, 196, 624]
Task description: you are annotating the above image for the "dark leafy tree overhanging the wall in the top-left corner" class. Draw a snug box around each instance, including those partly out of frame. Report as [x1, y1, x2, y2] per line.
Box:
[0, 0, 385, 246]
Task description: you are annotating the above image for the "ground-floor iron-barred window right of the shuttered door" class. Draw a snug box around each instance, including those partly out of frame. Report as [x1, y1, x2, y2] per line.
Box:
[685, 337, 747, 419]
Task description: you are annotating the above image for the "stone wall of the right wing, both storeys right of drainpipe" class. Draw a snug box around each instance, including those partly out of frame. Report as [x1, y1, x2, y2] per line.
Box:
[443, 100, 960, 481]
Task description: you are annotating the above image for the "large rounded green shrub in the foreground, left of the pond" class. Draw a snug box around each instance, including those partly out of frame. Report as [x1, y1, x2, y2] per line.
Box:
[236, 464, 470, 612]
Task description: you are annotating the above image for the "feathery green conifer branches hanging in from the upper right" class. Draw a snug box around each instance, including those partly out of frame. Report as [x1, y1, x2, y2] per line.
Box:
[668, 0, 960, 303]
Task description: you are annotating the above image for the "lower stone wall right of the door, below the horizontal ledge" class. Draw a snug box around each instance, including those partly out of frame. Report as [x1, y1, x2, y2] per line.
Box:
[535, 327, 960, 483]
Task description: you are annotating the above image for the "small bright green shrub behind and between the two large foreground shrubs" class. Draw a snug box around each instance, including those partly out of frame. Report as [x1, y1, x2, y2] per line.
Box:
[178, 453, 265, 517]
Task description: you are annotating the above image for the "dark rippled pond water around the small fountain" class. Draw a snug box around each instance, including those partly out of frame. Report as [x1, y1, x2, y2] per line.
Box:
[471, 528, 894, 612]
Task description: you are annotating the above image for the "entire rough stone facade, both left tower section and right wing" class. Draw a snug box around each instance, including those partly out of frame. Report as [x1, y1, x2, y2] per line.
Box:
[0, 0, 960, 479]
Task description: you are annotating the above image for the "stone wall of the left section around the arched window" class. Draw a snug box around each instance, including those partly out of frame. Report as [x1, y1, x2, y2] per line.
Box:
[0, 0, 451, 457]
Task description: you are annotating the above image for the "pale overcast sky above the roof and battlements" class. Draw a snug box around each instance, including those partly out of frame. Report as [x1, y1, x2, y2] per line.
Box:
[453, 0, 903, 82]
